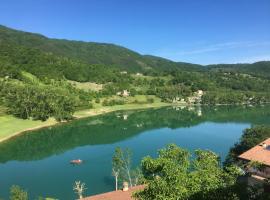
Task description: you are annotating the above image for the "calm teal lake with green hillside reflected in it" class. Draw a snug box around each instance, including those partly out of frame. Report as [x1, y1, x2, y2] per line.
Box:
[0, 106, 270, 200]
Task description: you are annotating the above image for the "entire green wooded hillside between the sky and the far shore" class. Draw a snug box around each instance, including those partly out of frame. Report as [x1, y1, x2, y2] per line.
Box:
[0, 26, 270, 121]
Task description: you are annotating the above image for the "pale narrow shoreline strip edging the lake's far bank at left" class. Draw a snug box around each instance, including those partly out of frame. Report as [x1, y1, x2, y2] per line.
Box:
[0, 102, 173, 143]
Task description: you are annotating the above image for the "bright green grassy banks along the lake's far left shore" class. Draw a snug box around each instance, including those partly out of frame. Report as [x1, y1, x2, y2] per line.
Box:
[0, 102, 171, 142]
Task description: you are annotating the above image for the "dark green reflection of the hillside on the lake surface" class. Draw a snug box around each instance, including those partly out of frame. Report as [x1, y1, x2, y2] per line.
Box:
[0, 106, 270, 163]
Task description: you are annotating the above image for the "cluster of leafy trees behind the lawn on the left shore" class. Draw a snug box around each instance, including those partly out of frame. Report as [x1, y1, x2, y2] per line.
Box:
[0, 76, 93, 121]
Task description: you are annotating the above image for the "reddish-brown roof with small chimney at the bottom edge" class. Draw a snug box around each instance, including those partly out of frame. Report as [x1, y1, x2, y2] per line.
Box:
[83, 185, 144, 200]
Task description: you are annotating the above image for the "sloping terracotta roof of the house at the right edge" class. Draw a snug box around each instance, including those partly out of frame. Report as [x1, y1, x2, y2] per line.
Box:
[238, 138, 270, 166]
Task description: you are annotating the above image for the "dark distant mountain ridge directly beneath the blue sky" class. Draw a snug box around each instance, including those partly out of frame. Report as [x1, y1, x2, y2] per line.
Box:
[0, 25, 270, 77]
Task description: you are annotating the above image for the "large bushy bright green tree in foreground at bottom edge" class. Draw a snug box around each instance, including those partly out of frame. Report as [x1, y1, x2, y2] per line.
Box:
[135, 144, 239, 200]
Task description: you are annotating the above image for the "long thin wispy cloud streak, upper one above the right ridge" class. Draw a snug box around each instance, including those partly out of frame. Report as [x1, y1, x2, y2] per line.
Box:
[159, 41, 270, 56]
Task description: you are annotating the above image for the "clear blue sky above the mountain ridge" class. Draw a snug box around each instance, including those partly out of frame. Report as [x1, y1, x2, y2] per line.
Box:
[0, 0, 270, 64]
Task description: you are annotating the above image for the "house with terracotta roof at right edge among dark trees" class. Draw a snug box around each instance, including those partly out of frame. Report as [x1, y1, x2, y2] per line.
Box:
[238, 138, 270, 191]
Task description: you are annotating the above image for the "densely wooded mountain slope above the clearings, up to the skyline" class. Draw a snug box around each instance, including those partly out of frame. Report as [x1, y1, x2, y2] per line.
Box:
[0, 25, 270, 82]
